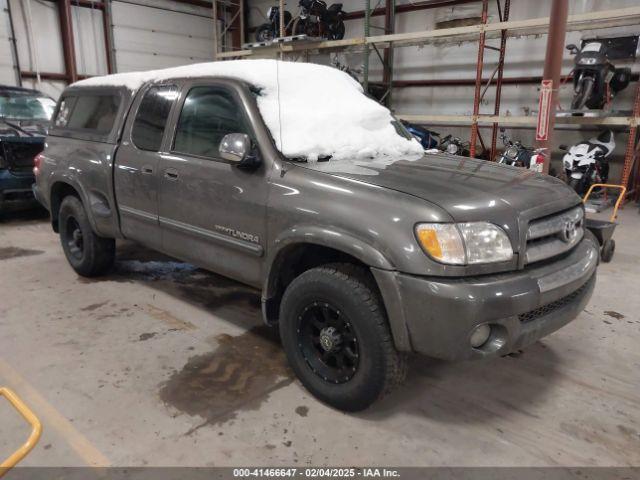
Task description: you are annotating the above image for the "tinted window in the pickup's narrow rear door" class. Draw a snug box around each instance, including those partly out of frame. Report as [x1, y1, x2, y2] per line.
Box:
[131, 85, 178, 152]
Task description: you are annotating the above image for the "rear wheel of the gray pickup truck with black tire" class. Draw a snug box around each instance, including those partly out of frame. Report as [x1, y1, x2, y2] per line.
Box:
[58, 195, 116, 277]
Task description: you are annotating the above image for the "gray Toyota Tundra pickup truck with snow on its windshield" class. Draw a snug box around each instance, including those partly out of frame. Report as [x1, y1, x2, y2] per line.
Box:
[34, 62, 599, 411]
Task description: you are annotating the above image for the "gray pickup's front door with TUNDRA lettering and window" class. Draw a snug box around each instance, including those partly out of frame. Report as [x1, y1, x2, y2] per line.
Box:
[159, 80, 269, 286]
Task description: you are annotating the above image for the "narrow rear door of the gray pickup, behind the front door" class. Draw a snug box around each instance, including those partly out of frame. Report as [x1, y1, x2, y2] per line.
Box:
[114, 85, 178, 249]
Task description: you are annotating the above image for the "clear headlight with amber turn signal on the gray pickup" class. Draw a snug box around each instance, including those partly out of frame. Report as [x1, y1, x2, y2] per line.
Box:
[416, 222, 513, 265]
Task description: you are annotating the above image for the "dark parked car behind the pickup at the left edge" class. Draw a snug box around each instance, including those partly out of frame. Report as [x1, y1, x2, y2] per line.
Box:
[0, 85, 56, 213]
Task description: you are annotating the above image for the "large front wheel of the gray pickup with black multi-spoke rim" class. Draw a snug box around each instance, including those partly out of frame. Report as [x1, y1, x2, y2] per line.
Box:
[279, 264, 407, 412]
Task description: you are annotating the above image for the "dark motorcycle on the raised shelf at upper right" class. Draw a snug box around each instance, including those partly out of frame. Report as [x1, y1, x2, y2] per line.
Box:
[567, 41, 631, 110]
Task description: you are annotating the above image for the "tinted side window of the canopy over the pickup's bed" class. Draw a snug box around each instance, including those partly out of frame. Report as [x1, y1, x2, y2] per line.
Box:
[55, 94, 120, 134]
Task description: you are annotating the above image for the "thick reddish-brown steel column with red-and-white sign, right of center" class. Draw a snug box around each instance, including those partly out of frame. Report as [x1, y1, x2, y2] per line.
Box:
[536, 0, 569, 173]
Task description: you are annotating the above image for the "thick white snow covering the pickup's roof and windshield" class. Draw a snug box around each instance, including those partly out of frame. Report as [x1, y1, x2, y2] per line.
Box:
[74, 60, 423, 163]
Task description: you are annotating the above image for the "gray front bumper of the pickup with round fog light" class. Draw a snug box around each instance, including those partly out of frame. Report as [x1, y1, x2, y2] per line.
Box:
[372, 237, 598, 360]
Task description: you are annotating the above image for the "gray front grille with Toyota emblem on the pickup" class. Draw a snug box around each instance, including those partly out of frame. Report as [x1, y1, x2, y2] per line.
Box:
[525, 205, 584, 264]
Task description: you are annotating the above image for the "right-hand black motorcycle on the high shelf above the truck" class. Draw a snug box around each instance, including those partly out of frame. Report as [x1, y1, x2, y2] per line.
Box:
[292, 0, 344, 40]
